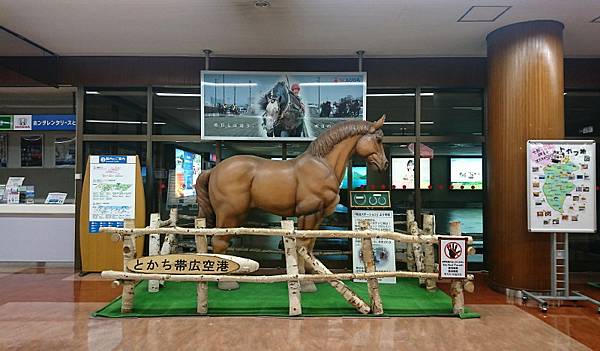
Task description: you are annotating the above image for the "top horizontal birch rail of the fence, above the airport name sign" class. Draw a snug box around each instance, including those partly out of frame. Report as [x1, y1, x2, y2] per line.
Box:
[100, 227, 473, 244]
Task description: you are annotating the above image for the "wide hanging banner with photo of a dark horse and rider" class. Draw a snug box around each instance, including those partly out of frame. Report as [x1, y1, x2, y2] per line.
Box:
[201, 71, 367, 140]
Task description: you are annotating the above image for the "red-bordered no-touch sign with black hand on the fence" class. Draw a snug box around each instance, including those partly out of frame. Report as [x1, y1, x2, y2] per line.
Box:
[438, 236, 467, 279]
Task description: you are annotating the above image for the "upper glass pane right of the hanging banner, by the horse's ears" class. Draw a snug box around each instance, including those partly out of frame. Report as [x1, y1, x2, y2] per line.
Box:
[367, 89, 415, 136]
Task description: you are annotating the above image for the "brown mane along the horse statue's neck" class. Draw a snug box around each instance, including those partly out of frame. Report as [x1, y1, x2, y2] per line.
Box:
[306, 120, 383, 157]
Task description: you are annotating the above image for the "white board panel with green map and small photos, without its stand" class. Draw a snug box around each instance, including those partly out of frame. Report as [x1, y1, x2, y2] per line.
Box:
[527, 140, 596, 233]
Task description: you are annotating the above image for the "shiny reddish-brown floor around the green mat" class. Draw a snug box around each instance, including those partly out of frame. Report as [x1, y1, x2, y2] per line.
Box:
[0, 265, 600, 350]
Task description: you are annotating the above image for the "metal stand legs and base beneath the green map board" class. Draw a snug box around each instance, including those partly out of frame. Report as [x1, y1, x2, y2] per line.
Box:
[521, 233, 600, 313]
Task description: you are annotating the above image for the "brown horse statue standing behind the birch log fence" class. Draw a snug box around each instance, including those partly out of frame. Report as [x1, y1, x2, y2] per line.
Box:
[195, 115, 388, 291]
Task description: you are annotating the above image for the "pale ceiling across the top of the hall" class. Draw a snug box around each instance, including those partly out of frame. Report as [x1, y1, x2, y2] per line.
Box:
[0, 0, 600, 57]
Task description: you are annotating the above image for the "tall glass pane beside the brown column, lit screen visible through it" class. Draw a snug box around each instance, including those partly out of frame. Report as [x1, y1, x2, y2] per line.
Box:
[421, 143, 485, 262]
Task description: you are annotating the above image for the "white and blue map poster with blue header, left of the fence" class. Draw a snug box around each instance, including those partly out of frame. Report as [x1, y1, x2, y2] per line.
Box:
[89, 156, 136, 233]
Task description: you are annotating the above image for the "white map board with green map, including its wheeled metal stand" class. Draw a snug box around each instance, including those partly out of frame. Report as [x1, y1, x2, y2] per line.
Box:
[522, 140, 600, 313]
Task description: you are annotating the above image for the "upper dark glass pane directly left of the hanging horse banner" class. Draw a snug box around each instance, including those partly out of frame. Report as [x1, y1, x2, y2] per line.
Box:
[152, 88, 200, 135]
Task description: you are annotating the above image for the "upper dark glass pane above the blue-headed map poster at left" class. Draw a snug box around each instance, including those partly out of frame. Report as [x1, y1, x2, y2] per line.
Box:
[84, 88, 148, 134]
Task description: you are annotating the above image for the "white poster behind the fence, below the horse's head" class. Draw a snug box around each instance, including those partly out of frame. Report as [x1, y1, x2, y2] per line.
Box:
[352, 210, 396, 284]
